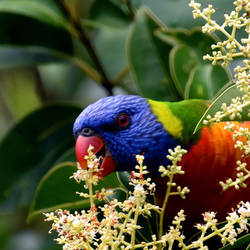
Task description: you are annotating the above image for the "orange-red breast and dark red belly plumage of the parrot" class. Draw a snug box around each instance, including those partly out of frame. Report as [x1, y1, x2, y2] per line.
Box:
[154, 122, 250, 226]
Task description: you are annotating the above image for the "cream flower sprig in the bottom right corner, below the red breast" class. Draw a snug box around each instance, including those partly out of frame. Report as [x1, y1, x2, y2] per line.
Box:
[162, 202, 250, 250]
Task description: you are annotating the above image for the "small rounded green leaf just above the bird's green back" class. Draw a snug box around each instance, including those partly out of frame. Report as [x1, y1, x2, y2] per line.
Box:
[185, 64, 230, 100]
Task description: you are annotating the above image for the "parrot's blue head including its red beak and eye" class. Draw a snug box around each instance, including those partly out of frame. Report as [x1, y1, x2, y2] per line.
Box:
[73, 95, 177, 176]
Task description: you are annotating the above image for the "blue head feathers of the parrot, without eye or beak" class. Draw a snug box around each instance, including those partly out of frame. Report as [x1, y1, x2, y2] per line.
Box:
[73, 95, 178, 175]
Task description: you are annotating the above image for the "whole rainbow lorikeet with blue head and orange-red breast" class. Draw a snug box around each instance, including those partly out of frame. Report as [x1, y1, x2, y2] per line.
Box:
[73, 95, 250, 226]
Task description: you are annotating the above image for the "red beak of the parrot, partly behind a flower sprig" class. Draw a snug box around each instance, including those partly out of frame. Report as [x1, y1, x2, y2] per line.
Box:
[75, 135, 116, 177]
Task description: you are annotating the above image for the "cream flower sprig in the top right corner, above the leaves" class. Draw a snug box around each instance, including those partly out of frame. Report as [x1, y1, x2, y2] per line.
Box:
[189, 0, 250, 65]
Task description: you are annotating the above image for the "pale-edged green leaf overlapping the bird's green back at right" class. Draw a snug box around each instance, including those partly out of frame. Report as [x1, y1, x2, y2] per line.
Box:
[194, 85, 249, 133]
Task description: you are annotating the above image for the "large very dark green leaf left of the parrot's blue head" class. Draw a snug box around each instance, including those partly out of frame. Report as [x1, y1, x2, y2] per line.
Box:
[0, 105, 81, 200]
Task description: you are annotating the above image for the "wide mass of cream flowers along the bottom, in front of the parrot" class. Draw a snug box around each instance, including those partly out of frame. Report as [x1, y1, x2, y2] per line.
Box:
[45, 146, 250, 250]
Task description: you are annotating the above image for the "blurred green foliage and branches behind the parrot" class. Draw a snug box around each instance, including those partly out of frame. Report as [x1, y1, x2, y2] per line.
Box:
[0, 0, 244, 250]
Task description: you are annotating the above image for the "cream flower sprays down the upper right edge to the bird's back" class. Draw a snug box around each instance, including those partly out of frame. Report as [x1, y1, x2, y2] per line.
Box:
[189, 0, 250, 125]
